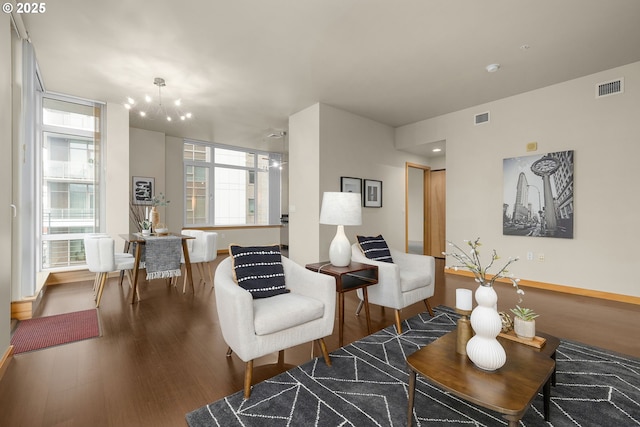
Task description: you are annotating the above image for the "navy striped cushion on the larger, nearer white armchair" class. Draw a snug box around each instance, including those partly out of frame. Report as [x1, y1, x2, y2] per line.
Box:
[229, 245, 289, 298]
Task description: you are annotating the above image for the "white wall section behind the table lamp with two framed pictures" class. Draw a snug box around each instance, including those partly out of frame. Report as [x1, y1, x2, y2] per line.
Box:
[289, 104, 428, 264]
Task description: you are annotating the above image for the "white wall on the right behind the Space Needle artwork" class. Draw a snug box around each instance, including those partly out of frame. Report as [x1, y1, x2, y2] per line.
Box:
[396, 62, 640, 297]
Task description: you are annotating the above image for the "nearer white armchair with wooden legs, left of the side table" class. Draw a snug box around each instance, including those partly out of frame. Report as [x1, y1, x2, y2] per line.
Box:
[214, 257, 336, 399]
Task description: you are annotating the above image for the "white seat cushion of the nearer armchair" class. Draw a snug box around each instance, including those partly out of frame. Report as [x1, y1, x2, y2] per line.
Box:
[253, 293, 324, 335]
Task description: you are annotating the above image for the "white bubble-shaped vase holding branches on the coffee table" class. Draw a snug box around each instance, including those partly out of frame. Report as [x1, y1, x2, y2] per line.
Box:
[467, 285, 507, 371]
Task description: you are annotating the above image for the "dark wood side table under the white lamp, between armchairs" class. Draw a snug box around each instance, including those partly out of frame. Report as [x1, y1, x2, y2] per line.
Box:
[305, 261, 378, 347]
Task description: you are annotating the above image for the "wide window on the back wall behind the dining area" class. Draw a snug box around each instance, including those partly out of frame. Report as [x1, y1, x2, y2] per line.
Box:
[184, 141, 281, 226]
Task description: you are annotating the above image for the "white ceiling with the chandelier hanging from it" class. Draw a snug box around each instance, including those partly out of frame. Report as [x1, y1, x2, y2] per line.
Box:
[22, 0, 640, 155]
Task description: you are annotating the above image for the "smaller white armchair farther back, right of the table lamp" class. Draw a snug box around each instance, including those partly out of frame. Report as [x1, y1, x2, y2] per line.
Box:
[351, 243, 436, 334]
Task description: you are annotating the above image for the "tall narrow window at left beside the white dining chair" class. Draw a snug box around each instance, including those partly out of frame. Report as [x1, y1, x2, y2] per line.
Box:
[40, 94, 102, 269]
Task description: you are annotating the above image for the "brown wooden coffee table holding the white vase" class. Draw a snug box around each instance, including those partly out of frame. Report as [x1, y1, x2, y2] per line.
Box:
[407, 330, 560, 427]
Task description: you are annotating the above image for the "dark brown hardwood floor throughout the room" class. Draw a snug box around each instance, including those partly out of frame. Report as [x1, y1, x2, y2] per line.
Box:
[0, 257, 640, 427]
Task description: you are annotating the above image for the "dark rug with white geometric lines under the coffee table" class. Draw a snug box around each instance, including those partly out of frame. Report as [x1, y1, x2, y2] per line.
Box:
[186, 307, 640, 427]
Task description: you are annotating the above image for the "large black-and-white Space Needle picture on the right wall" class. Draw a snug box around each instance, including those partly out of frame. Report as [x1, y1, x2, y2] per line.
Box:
[502, 150, 574, 239]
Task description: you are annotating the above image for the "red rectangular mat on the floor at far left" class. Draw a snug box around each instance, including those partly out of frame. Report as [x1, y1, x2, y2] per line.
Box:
[11, 309, 100, 354]
